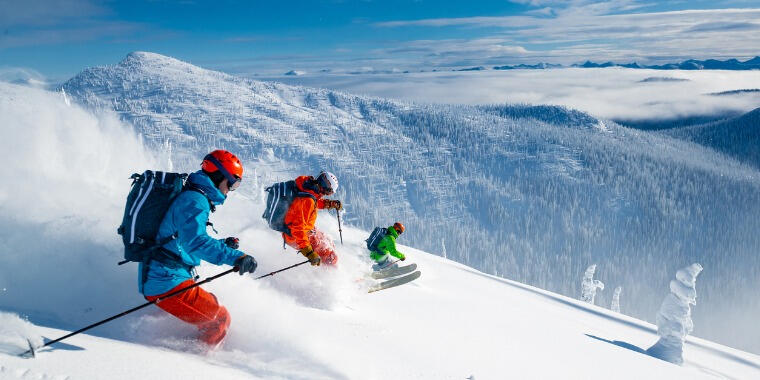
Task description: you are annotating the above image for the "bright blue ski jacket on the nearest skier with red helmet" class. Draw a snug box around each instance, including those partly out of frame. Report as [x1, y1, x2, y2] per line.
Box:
[138, 170, 244, 296]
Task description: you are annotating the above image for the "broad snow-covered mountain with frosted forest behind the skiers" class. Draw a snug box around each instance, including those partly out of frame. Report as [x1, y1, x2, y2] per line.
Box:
[59, 53, 760, 352]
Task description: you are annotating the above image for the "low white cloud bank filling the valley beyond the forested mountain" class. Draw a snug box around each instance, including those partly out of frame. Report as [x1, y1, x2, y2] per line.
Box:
[268, 68, 760, 119]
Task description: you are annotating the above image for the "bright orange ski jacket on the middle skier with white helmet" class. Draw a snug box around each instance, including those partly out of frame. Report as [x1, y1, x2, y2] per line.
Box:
[282, 175, 325, 249]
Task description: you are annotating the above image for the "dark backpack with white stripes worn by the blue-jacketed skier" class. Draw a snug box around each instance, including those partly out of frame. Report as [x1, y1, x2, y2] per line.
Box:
[117, 170, 191, 266]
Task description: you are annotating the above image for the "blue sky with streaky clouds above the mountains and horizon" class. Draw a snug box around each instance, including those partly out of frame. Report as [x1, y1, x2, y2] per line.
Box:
[0, 0, 760, 80]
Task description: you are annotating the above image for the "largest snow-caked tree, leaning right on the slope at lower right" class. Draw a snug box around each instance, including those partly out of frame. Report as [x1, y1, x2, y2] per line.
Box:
[647, 263, 702, 364]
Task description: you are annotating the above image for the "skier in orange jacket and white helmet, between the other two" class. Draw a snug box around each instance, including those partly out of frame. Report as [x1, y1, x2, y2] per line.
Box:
[282, 171, 343, 265]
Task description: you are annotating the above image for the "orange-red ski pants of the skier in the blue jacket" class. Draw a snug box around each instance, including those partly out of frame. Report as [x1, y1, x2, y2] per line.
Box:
[145, 279, 230, 345]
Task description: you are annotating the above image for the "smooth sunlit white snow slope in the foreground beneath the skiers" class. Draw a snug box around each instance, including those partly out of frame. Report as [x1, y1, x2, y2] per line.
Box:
[0, 242, 760, 380]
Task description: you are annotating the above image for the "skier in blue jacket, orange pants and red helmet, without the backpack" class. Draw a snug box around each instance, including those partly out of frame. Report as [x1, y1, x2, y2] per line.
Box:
[139, 150, 257, 346]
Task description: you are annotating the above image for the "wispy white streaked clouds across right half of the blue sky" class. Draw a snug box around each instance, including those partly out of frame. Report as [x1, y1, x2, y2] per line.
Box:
[375, 0, 760, 63]
